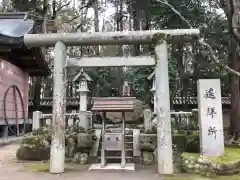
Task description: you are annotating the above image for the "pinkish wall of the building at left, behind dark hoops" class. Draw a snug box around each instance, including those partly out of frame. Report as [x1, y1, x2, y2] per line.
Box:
[0, 59, 29, 124]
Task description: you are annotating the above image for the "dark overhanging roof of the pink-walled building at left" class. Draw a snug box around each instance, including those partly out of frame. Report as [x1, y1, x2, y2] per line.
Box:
[0, 12, 50, 76]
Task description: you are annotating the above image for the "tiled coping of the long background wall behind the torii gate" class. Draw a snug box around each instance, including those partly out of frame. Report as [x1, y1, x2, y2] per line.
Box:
[29, 97, 231, 107]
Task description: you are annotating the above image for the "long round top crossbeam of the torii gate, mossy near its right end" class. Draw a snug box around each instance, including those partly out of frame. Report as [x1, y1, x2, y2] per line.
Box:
[24, 29, 200, 47]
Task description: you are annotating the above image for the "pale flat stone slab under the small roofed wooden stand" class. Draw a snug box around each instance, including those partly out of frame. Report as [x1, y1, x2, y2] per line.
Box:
[89, 163, 135, 171]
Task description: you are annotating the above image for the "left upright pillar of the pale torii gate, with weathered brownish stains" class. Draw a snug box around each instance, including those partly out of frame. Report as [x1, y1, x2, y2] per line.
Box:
[50, 41, 67, 174]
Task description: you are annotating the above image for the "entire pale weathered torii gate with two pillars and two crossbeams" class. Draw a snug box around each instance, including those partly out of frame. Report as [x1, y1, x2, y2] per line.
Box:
[24, 29, 200, 174]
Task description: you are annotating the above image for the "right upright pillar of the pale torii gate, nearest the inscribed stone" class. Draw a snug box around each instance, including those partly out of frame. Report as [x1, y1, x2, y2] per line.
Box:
[155, 40, 173, 174]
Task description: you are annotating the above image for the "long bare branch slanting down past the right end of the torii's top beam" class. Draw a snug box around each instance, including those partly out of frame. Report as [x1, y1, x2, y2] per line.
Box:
[156, 0, 240, 77]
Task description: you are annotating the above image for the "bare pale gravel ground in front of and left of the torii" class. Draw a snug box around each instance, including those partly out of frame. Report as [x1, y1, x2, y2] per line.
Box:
[0, 144, 164, 180]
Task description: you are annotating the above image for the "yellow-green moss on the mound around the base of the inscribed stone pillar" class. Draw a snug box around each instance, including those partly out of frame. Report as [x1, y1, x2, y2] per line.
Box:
[181, 148, 240, 164]
